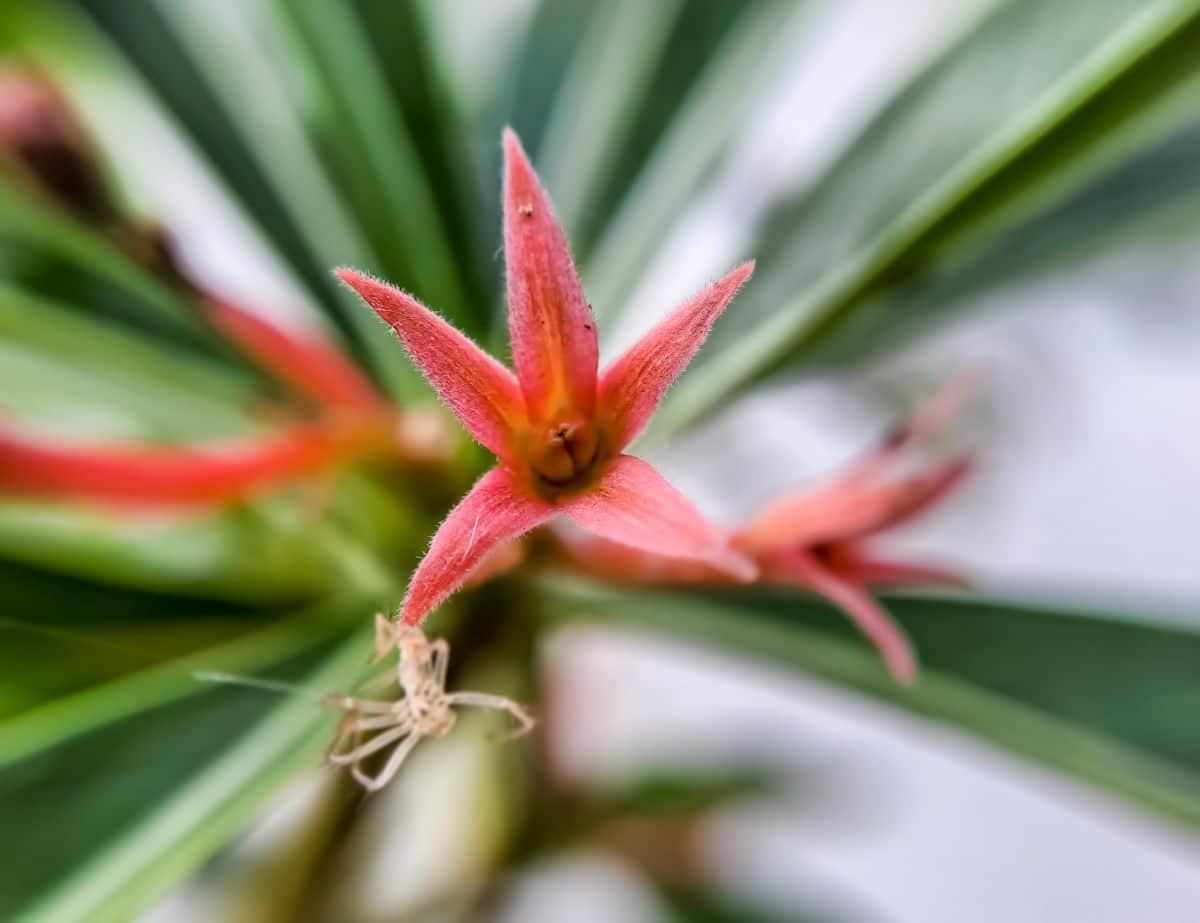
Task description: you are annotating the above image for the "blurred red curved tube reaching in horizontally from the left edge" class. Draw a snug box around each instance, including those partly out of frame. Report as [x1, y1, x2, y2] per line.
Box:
[0, 426, 355, 508]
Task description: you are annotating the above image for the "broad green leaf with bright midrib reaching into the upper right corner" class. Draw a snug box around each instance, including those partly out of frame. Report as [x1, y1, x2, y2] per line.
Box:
[660, 0, 1200, 430]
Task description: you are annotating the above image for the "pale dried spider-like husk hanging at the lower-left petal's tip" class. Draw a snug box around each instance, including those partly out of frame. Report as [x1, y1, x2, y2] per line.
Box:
[325, 615, 535, 792]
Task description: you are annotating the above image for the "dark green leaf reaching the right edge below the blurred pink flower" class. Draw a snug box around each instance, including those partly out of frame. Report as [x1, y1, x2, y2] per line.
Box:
[556, 586, 1200, 827]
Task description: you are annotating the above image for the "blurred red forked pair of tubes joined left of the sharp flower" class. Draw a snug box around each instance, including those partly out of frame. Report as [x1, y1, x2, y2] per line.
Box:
[0, 299, 449, 509]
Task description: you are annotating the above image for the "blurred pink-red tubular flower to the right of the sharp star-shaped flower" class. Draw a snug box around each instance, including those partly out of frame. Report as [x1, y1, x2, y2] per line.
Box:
[556, 373, 978, 683]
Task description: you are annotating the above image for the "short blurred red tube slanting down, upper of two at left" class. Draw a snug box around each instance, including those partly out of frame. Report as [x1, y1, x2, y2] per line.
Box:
[206, 299, 384, 410]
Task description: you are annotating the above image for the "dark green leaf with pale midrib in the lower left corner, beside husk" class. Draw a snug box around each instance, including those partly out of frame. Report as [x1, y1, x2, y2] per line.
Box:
[0, 612, 368, 923]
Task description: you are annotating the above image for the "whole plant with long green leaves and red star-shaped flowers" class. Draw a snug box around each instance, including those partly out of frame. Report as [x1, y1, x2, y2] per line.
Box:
[7, 0, 1200, 922]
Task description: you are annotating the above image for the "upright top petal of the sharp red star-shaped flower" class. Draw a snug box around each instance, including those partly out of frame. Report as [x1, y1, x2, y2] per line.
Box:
[504, 130, 599, 419]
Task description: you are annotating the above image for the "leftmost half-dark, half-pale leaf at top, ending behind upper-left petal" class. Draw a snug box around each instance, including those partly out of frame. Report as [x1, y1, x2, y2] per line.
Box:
[70, 0, 420, 395]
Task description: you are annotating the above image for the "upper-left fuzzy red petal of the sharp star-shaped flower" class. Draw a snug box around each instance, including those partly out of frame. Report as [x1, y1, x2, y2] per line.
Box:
[336, 269, 524, 458]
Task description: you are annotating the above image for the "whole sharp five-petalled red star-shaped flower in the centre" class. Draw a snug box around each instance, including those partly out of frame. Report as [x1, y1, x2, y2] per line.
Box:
[337, 131, 754, 624]
